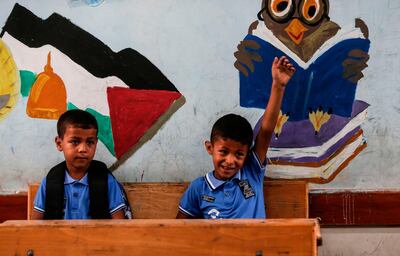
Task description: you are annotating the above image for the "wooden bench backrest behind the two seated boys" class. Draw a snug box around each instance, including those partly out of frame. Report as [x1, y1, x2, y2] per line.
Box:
[27, 180, 308, 220]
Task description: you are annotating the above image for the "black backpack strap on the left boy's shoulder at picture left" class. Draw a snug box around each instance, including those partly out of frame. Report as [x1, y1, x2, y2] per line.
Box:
[43, 161, 67, 220]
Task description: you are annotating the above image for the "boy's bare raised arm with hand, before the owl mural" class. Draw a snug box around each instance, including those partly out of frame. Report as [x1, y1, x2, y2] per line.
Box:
[254, 56, 296, 163]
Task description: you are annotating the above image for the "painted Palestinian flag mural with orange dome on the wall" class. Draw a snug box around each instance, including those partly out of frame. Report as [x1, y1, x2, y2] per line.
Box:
[0, 4, 184, 160]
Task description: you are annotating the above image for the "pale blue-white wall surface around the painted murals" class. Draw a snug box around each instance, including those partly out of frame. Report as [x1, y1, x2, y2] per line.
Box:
[0, 0, 400, 193]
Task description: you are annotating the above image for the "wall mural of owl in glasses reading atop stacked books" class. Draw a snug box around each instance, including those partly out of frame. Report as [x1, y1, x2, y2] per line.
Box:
[234, 0, 370, 183]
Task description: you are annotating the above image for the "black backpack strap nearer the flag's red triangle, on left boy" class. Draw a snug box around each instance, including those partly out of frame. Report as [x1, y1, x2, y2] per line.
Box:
[88, 160, 111, 219]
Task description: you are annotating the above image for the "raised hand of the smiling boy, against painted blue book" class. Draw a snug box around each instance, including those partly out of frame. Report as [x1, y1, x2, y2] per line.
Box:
[271, 56, 296, 87]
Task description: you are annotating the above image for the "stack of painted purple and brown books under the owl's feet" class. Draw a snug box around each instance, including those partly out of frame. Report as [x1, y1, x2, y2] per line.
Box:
[255, 100, 369, 183]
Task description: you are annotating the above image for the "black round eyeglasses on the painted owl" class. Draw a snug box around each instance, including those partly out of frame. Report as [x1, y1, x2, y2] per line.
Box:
[257, 1, 329, 26]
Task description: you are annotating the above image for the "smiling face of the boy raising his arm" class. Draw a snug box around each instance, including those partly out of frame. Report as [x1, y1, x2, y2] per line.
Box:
[205, 137, 249, 180]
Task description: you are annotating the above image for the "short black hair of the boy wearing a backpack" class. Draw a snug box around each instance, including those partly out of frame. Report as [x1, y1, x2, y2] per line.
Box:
[57, 109, 99, 138]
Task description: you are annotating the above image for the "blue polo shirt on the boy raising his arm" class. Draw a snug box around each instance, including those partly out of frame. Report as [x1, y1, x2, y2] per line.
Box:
[179, 151, 265, 219]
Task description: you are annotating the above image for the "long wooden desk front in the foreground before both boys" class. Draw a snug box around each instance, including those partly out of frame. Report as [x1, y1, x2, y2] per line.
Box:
[0, 219, 320, 256]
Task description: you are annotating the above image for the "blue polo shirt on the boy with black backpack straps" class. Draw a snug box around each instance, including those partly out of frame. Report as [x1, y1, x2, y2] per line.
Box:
[33, 171, 126, 220]
